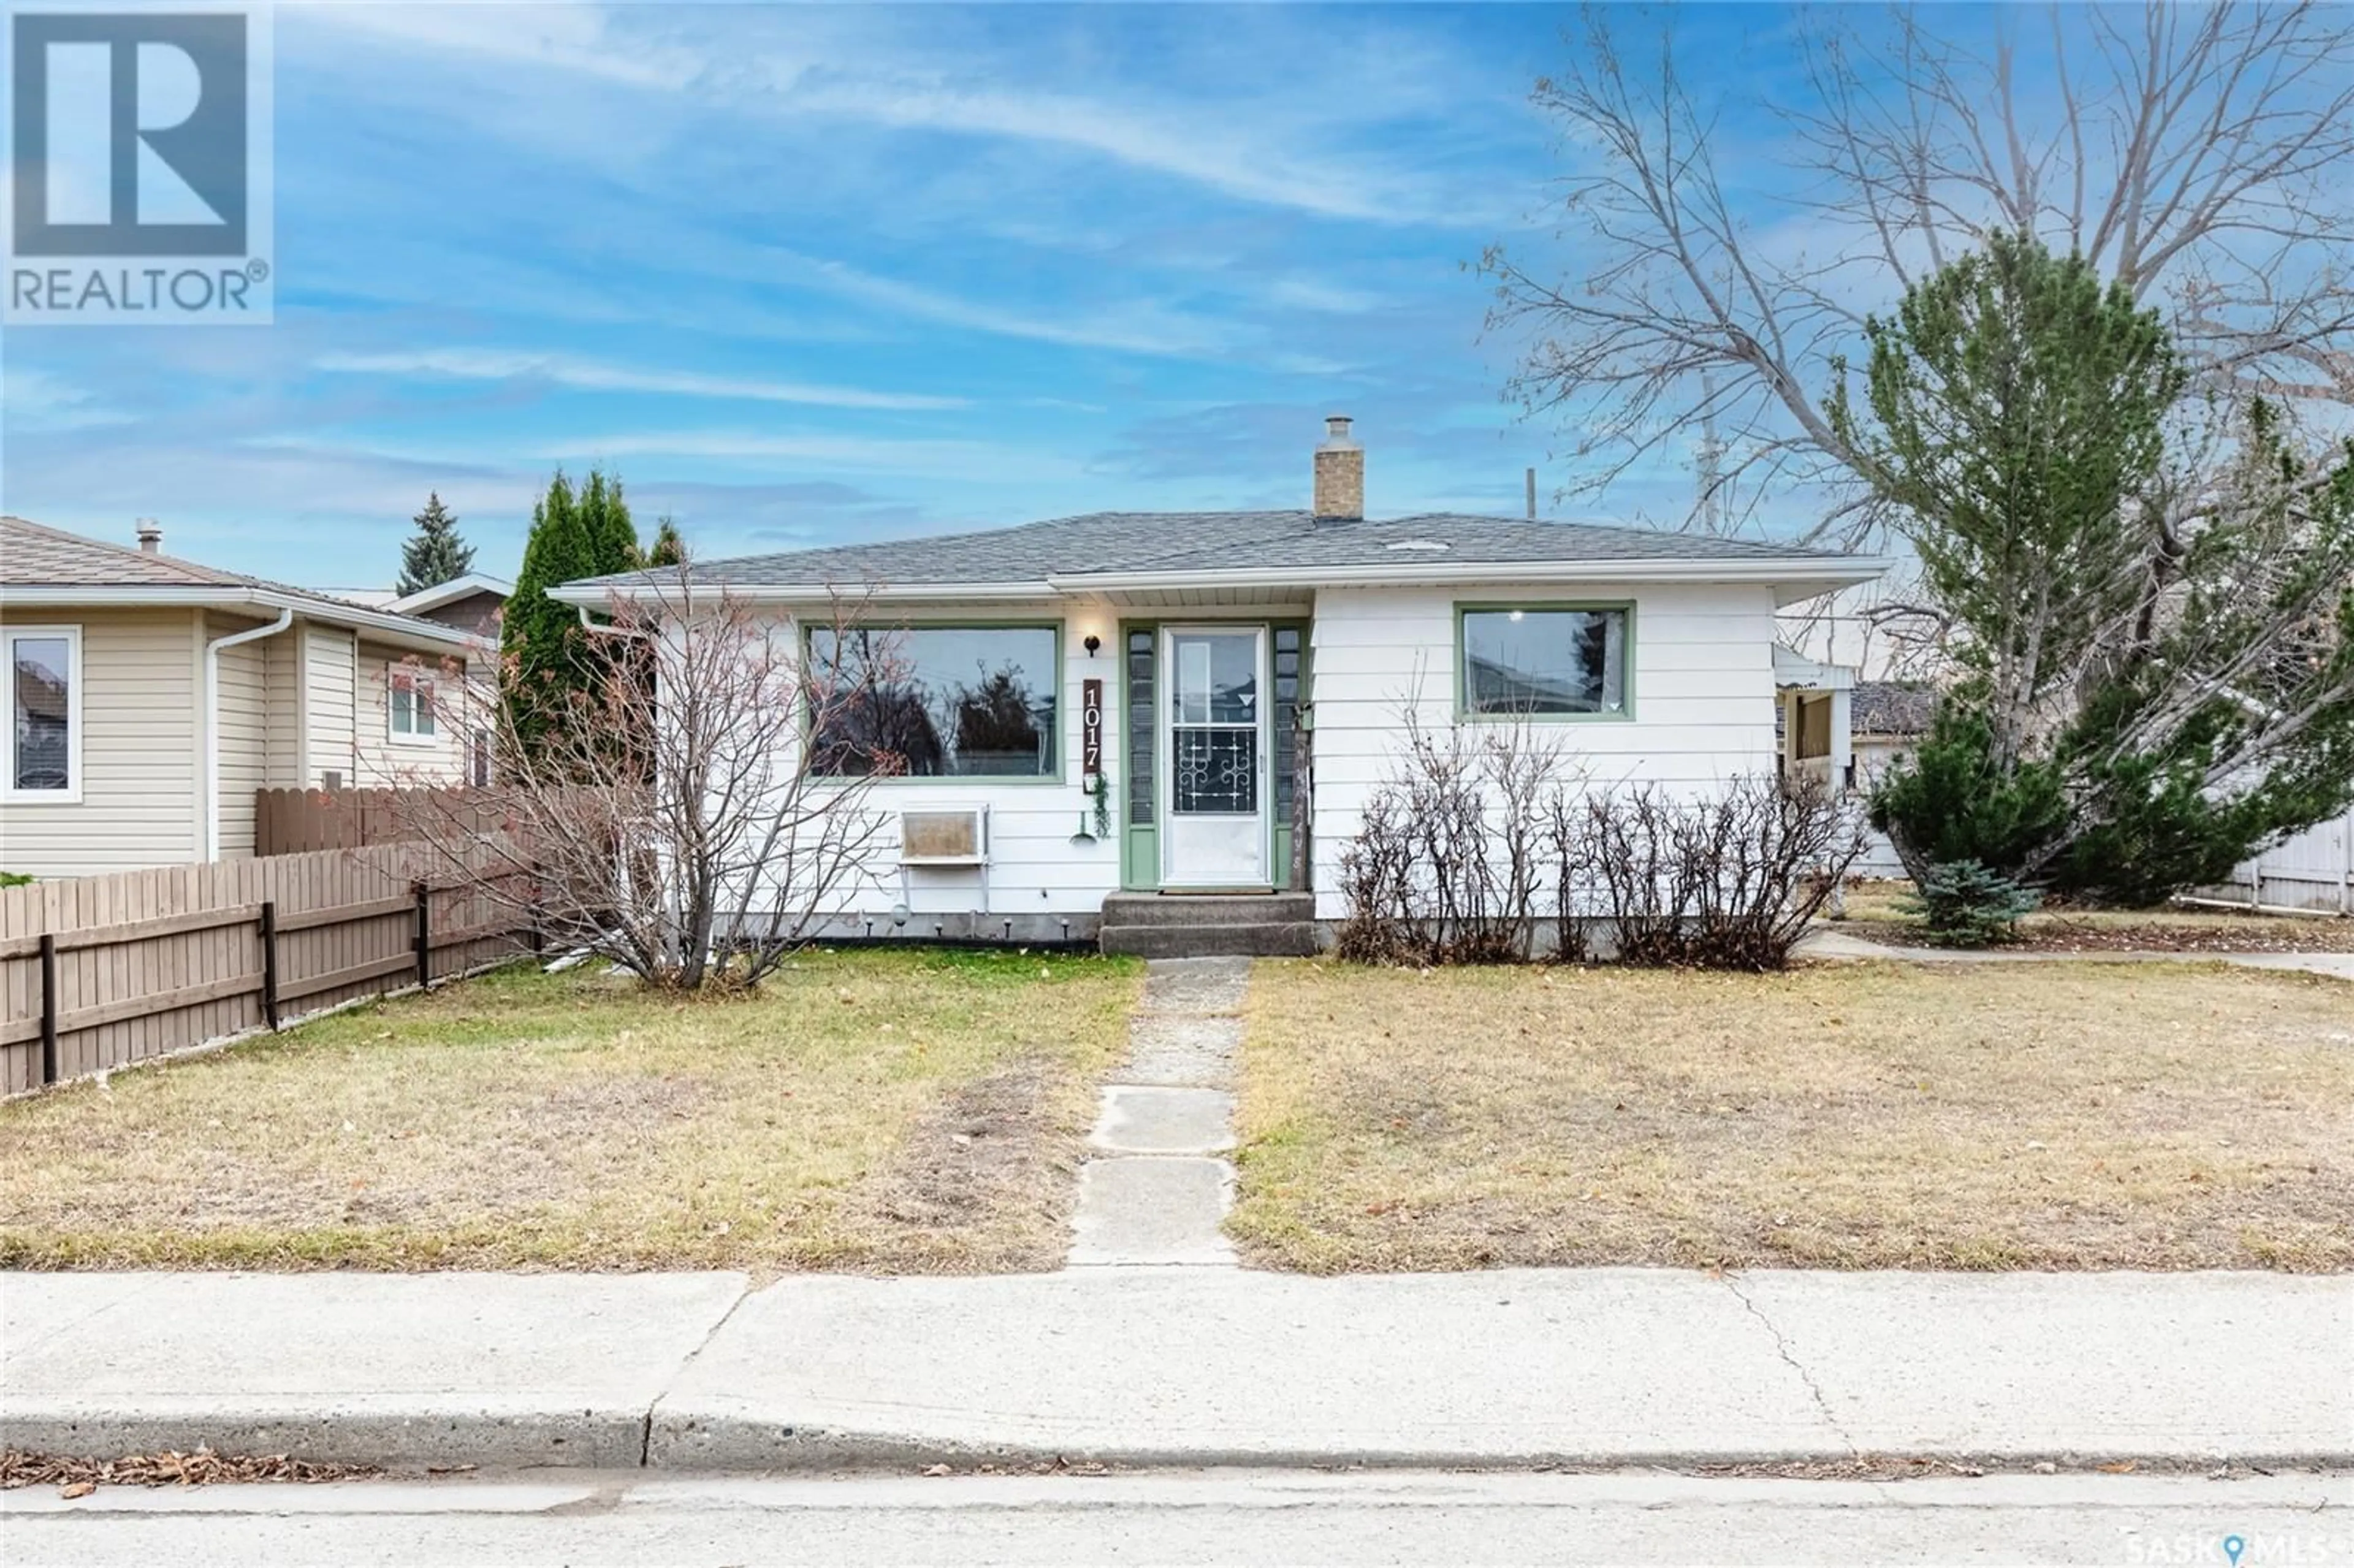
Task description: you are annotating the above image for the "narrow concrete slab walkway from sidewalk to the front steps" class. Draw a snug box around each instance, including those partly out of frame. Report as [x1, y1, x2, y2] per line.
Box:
[1071, 958, 1250, 1269]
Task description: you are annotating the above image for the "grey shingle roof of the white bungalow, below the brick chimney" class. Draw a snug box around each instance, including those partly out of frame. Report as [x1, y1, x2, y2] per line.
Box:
[577, 511, 1848, 588]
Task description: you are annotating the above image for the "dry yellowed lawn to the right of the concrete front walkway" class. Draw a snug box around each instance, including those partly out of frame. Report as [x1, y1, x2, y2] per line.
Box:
[1228, 963, 2354, 1271]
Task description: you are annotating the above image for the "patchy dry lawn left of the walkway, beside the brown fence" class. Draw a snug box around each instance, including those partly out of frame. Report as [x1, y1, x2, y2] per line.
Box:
[0, 951, 1140, 1274]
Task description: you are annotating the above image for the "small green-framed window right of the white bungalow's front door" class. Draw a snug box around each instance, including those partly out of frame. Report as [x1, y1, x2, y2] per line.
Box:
[1457, 605, 1631, 718]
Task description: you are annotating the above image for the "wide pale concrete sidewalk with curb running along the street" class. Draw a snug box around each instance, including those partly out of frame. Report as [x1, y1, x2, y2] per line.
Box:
[0, 1269, 2354, 1469]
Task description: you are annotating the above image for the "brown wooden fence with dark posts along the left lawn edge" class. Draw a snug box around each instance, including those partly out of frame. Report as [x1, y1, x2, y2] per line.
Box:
[0, 845, 532, 1092]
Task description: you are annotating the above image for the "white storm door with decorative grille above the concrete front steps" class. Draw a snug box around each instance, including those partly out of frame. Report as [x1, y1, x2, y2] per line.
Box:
[1160, 626, 1273, 888]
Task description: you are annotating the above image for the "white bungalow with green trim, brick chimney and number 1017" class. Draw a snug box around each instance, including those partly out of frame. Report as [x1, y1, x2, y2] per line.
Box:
[553, 417, 1883, 951]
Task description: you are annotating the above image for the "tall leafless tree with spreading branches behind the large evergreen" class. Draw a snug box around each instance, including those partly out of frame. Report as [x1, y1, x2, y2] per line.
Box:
[1485, 2, 2354, 544]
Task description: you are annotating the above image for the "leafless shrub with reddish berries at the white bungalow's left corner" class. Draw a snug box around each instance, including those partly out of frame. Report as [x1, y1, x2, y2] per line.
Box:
[403, 568, 890, 991]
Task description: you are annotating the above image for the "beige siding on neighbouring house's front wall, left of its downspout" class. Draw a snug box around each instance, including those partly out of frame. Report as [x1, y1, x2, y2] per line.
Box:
[0, 610, 202, 876]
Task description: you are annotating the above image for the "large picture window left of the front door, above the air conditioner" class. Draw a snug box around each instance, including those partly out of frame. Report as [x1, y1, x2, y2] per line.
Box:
[810, 626, 1062, 779]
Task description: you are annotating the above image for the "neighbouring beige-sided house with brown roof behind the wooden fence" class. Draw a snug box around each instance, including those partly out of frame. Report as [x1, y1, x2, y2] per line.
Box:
[0, 518, 482, 876]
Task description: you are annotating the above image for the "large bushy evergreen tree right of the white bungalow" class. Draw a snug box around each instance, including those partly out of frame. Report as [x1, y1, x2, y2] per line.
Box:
[1829, 235, 2354, 904]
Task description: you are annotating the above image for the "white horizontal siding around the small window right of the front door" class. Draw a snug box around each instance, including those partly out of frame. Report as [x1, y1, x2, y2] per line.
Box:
[1311, 584, 1775, 918]
